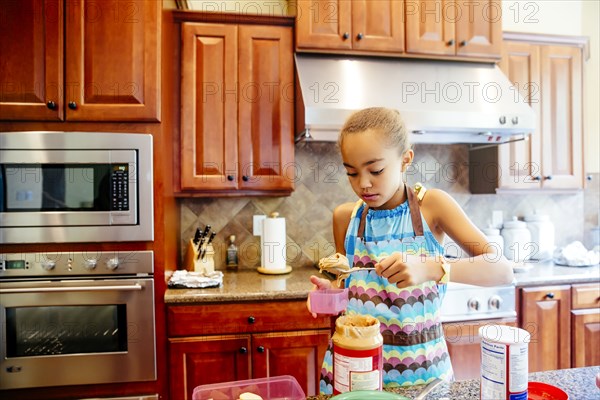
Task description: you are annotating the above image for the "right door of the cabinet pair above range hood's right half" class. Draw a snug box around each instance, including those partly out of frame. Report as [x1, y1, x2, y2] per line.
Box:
[454, 0, 502, 58]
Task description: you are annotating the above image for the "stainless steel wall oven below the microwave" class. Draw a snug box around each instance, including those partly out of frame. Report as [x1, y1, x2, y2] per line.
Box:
[0, 251, 156, 389]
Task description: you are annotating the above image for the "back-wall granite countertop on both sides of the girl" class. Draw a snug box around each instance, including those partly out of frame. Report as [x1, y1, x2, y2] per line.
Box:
[165, 262, 600, 304]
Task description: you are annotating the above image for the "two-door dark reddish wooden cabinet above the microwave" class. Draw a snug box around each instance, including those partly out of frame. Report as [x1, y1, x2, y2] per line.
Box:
[0, 0, 162, 121]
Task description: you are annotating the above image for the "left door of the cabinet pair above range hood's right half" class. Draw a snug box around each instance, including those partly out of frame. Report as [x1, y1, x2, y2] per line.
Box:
[405, 0, 452, 55]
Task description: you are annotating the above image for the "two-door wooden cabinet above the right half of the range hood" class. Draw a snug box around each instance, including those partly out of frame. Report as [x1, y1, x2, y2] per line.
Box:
[405, 0, 502, 58]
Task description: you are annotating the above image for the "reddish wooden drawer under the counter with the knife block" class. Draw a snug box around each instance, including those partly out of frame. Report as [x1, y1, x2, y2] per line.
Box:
[167, 300, 331, 337]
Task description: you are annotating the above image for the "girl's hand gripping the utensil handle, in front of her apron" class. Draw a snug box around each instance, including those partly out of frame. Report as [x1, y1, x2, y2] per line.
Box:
[375, 252, 443, 288]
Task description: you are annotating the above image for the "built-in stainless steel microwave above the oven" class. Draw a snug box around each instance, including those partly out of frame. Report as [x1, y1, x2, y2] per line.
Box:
[0, 131, 154, 243]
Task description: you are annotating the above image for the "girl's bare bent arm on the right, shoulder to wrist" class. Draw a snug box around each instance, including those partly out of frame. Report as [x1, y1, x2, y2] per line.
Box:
[421, 189, 514, 286]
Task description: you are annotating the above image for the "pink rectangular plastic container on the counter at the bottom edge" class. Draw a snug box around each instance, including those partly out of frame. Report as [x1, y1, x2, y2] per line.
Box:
[192, 375, 306, 400]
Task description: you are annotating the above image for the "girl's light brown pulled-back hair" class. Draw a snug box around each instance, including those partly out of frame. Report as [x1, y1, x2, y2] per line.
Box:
[338, 107, 410, 153]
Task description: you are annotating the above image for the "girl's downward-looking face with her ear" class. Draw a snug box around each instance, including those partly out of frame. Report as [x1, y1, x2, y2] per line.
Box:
[341, 130, 413, 209]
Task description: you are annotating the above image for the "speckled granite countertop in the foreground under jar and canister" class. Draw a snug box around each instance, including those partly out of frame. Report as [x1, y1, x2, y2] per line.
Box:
[307, 367, 600, 400]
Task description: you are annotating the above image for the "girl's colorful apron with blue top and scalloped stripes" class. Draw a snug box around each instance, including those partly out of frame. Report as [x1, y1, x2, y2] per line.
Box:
[320, 189, 453, 394]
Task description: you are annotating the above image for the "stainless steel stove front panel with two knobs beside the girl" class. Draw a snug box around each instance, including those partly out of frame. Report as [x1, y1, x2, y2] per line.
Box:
[440, 282, 517, 322]
